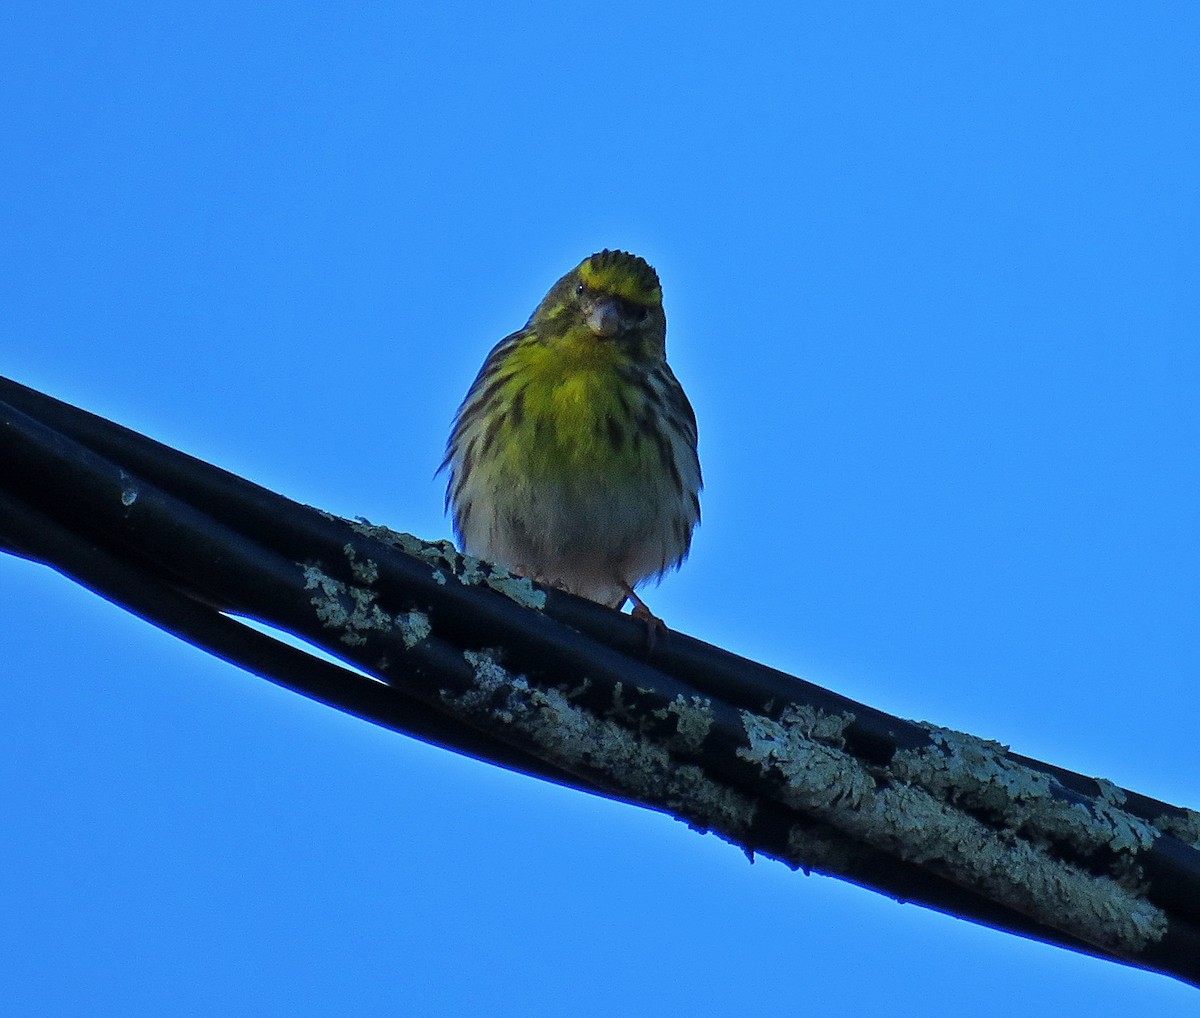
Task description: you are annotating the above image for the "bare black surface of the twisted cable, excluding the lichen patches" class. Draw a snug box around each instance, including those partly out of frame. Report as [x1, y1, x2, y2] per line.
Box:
[0, 379, 1200, 982]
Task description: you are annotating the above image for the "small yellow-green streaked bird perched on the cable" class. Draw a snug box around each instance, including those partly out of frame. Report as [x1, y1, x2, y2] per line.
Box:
[442, 251, 702, 618]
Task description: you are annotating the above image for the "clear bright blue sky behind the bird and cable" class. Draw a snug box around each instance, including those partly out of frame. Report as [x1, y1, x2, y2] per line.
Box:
[0, 2, 1200, 1016]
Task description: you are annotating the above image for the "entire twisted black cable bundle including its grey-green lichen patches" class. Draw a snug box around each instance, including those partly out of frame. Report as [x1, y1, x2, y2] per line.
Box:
[0, 379, 1200, 982]
